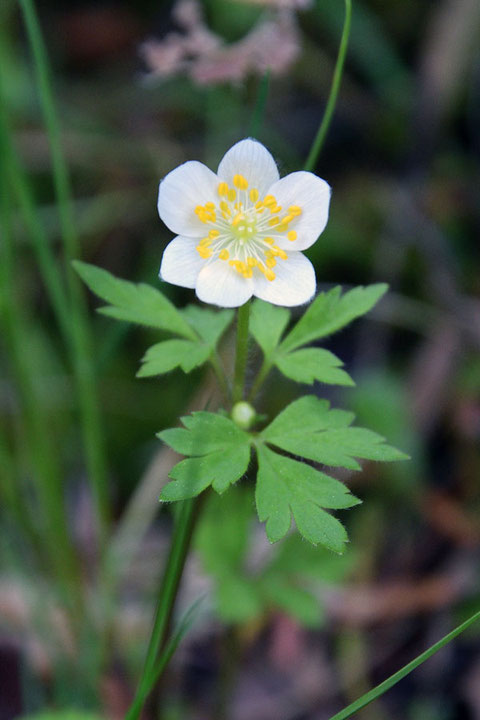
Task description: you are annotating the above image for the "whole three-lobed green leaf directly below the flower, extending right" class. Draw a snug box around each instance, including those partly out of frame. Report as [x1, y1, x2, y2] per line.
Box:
[250, 284, 387, 386]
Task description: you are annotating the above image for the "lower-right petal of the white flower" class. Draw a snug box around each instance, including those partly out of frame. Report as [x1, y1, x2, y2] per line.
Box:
[253, 252, 316, 307]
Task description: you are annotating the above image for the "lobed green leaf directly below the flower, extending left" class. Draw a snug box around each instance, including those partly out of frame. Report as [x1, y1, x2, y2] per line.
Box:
[73, 261, 233, 377]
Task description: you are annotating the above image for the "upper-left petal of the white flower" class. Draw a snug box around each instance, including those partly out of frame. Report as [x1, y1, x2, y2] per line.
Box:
[158, 160, 218, 237]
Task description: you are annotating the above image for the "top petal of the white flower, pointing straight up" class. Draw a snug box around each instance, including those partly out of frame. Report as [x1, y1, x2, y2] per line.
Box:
[217, 138, 280, 198]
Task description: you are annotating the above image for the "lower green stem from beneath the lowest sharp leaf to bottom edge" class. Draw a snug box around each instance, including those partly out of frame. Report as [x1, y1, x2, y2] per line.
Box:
[125, 493, 205, 720]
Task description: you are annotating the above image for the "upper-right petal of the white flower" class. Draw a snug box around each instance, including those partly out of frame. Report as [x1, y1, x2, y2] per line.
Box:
[269, 170, 331, 251]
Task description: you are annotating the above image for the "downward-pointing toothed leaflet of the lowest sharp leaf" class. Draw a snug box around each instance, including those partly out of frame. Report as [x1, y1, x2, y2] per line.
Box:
[255, 445, 359, 553]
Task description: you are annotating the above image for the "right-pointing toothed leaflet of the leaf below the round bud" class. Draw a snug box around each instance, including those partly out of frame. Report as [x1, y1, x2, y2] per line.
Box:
[260, 395, 408, 470]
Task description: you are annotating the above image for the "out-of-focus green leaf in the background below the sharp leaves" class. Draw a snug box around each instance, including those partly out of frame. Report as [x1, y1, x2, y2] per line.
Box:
[195, 485, 351, 627]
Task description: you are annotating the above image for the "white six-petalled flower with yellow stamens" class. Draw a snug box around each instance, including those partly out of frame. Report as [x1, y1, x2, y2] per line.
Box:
[158, 139, 330, 307]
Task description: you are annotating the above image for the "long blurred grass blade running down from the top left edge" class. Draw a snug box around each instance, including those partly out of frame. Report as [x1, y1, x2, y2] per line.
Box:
[20, 0, 110, 547]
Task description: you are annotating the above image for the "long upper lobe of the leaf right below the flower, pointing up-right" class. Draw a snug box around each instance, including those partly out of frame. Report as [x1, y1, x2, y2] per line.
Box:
[280, 283, 388, 351]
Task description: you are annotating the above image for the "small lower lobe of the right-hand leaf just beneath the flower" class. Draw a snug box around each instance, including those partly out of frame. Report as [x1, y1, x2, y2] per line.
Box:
[275, 348, 355, 386]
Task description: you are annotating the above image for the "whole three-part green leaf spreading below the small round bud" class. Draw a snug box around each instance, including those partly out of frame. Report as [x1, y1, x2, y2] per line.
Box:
[159, 395, 406, 553]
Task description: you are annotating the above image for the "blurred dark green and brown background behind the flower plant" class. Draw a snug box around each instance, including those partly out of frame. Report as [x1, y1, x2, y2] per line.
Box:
[0, 0, 480, 720]
